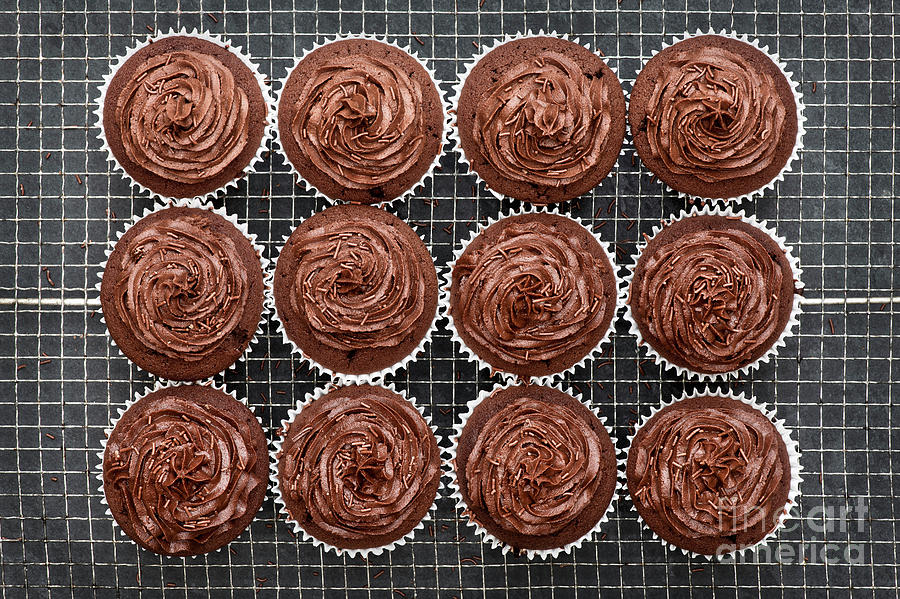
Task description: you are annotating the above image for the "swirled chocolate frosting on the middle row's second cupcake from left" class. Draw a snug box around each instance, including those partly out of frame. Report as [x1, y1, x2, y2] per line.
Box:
[290, 220, 433, 351]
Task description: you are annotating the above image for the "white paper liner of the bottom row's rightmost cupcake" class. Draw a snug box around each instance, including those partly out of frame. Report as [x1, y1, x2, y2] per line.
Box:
[626, 388, 803, 561]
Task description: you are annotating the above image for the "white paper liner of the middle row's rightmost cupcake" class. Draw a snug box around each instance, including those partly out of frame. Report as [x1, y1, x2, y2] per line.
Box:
[623, 205, 803, 381]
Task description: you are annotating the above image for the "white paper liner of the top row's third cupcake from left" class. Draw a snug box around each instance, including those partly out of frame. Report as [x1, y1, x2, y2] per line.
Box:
[450, 29, 629, 206]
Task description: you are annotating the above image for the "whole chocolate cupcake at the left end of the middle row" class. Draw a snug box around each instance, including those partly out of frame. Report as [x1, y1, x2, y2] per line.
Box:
[99, 200, 268, 381]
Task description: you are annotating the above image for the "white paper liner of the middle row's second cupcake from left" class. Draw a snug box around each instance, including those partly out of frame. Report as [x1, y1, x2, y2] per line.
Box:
[266, 205, 441, 385]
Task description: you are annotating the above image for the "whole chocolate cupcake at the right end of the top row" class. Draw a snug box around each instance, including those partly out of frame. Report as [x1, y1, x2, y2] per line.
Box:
[629, 32, 803, 199]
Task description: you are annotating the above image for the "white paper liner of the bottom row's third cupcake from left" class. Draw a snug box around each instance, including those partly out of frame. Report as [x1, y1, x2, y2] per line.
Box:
[447, 383, 625, 560]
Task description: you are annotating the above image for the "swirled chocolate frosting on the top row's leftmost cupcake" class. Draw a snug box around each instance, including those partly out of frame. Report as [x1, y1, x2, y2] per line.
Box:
[115, 50, 251, 184]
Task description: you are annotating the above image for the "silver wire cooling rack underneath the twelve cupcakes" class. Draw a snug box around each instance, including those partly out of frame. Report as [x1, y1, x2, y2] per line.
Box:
[0, 0, 900, 599]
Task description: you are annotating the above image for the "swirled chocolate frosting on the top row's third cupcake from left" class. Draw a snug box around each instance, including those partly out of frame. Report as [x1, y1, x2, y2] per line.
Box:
[472, 50, 612, 186]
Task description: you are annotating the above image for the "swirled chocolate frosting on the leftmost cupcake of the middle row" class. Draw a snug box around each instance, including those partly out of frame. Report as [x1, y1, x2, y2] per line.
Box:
[111, 208, 262, 364]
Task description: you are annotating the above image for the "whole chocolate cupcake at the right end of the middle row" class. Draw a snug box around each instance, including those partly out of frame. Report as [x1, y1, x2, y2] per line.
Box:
[625, 208, 802, 379]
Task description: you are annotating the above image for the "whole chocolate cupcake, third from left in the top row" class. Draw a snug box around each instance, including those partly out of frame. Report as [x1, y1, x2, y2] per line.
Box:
[452, 34, 625, 204]
